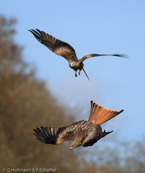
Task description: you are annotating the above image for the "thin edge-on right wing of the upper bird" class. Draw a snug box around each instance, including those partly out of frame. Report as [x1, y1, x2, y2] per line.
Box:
[79, 53, 126, 63]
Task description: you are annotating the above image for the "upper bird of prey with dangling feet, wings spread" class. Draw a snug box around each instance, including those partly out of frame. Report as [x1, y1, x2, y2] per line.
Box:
[29, 29, 124, 79]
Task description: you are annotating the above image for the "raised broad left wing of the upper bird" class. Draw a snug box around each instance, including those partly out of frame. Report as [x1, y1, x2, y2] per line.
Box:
[29, 29, 77, 62]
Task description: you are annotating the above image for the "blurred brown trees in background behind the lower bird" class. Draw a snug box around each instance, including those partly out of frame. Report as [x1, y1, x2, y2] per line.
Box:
[0, 15, 145, 173]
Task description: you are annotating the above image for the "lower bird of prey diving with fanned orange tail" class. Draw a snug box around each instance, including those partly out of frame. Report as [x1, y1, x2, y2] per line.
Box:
[33, 101, 124, 149]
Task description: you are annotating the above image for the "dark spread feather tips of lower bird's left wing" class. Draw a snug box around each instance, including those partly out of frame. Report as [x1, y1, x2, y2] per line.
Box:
[33, 126, 65, 144]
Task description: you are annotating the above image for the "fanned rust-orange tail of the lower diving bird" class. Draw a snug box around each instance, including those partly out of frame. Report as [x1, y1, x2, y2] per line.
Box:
[88, 101, 124, 125]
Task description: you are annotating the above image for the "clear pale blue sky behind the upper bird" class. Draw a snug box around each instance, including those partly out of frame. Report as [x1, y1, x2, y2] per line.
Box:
[0, 0, 145, 140]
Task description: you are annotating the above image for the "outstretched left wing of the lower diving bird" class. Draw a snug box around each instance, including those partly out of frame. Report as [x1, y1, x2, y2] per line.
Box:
[33, 121, 81, 145]
